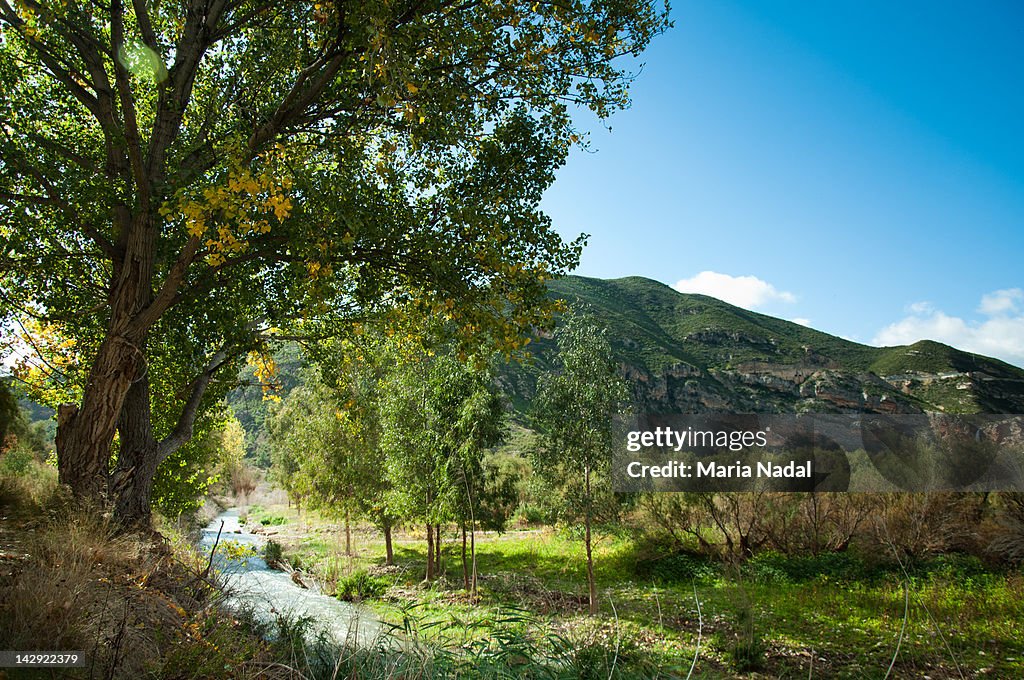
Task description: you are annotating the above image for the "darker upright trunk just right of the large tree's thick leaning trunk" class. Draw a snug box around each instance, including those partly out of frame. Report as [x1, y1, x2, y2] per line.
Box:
[110, 373, 160, 528]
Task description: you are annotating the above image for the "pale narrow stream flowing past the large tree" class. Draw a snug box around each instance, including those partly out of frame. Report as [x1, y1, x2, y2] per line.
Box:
[200, 509, 383, 646]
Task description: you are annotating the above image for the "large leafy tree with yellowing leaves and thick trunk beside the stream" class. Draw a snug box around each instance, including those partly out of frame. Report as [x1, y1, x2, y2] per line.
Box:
[0, 0, 667, 520]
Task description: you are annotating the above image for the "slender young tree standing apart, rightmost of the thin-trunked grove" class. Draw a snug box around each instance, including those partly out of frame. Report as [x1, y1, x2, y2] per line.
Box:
[535, 310, 629, 614]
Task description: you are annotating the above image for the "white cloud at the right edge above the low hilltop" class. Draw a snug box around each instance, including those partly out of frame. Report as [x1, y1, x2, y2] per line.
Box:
[871, 288, 1024, 367]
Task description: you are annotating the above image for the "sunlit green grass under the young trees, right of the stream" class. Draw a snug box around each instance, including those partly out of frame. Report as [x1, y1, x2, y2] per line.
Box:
[258, 501, 1024, 678]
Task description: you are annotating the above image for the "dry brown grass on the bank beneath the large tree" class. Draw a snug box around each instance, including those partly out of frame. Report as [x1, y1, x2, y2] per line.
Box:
[0, 483, 276, 679]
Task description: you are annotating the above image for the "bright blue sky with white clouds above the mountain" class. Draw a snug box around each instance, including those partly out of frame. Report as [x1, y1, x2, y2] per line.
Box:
[543, 0, 1024, 367]
